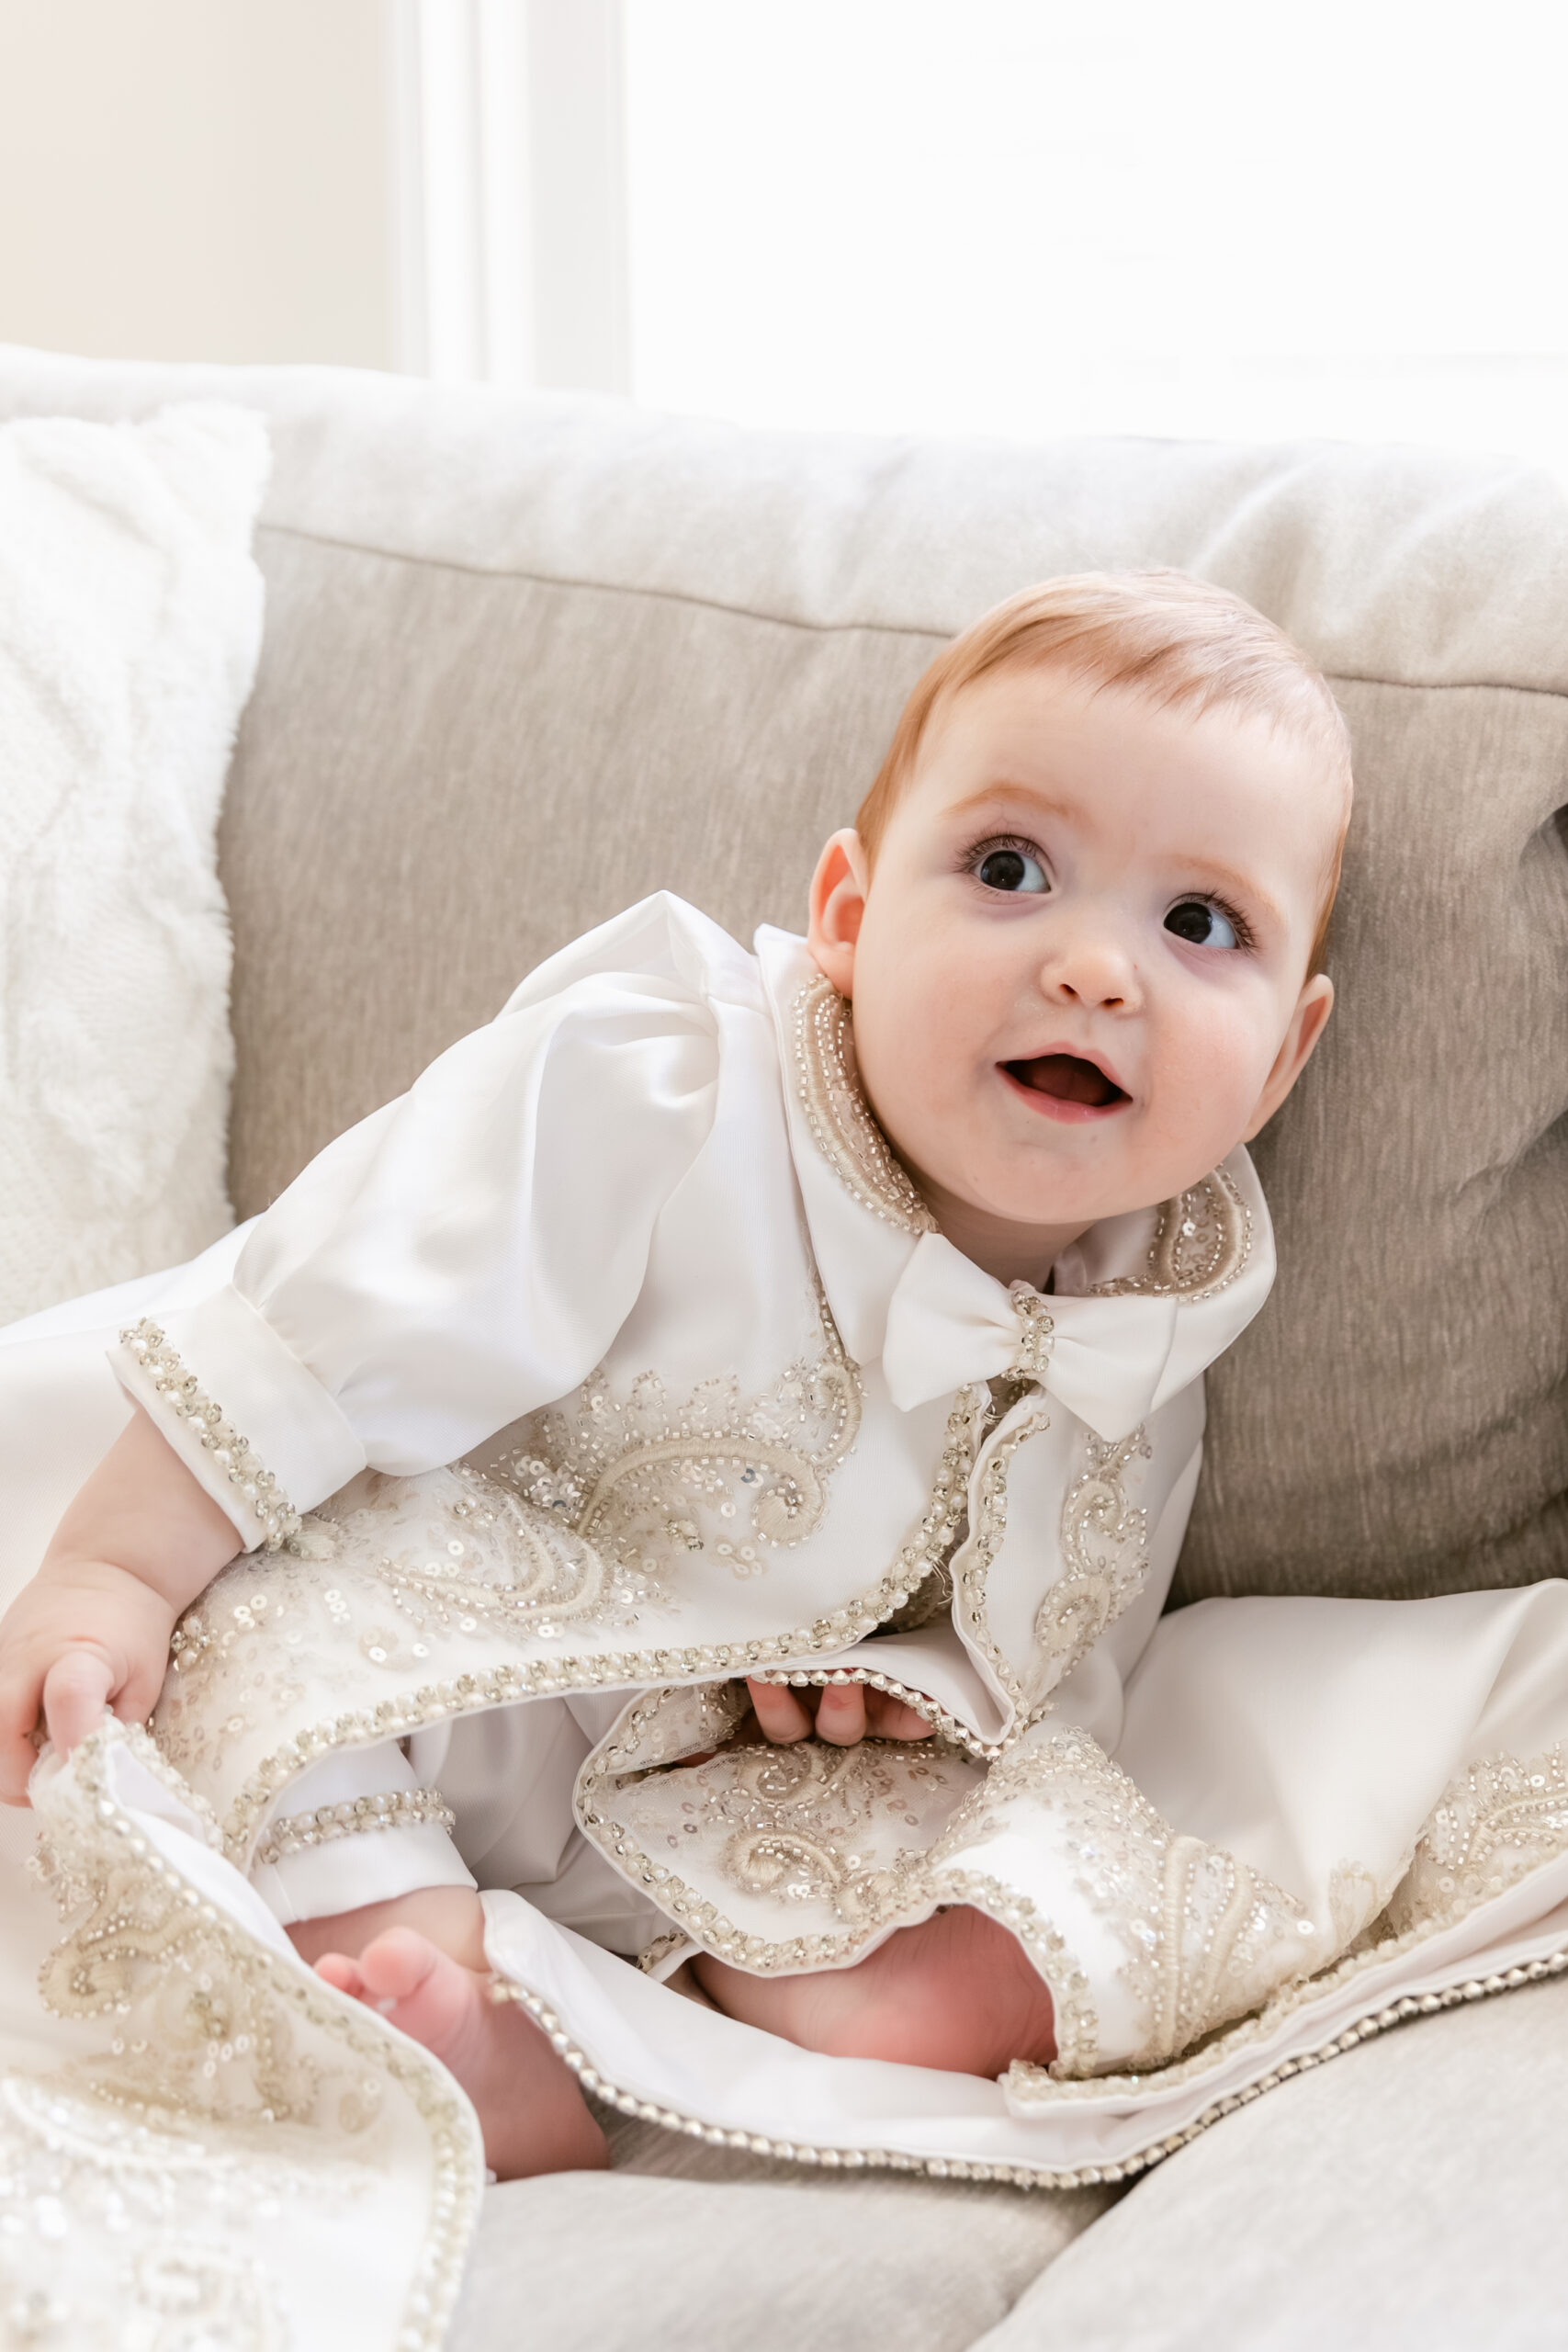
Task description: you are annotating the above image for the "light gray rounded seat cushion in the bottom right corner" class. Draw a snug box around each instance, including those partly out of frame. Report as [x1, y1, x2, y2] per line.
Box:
[976, 1981, 1568, 2352]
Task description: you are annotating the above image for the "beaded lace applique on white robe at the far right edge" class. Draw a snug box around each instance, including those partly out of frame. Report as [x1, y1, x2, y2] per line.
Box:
[1380, 1747, 1568, 1936]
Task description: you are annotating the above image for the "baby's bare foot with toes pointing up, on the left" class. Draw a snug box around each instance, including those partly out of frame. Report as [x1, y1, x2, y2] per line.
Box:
[315, 1927, 609, 2180]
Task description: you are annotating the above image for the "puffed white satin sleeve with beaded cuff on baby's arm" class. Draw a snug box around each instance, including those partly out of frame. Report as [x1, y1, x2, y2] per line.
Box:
[113, 894, 752, 1545]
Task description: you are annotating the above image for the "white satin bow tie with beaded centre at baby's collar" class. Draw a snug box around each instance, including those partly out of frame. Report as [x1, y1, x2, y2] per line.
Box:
[882, 1232, 1189, 1444]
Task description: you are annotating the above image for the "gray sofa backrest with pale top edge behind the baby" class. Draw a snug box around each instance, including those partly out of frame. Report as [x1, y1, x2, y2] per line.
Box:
[0, 353, 1568, 1600]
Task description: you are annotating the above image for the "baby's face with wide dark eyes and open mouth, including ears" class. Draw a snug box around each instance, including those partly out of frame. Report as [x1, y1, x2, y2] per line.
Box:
[811, 671, 1342, 1263]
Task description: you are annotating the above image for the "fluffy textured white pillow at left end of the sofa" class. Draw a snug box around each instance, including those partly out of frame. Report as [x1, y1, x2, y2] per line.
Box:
[0, 402, 268, 1324]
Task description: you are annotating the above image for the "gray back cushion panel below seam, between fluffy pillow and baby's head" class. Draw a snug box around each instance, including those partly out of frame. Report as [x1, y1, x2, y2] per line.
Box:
[221, 529, 938, 1214]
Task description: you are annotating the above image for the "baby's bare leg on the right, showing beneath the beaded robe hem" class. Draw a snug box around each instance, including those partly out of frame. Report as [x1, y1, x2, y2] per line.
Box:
[691, 1905, 1055, 2076]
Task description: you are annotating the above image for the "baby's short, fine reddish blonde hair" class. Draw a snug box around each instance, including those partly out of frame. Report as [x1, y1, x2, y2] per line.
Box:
[856, 571, 1352, 974]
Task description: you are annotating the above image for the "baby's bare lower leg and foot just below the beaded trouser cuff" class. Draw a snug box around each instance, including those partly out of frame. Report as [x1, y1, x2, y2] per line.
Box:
[289, 1886, 609, 2180]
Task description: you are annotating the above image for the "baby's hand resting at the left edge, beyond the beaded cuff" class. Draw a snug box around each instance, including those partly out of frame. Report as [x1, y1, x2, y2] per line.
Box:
[0, 1559, 179, 1804]
